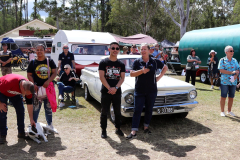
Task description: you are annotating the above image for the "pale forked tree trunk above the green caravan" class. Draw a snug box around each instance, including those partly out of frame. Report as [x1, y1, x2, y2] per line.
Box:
[161, 0, 190, 39]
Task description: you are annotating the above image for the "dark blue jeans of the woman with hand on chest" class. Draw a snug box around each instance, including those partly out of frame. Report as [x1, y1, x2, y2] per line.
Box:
[132, 92, 157, 131]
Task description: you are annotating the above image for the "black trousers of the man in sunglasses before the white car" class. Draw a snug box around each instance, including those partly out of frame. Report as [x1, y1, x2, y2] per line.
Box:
[100, 93, 121, 130]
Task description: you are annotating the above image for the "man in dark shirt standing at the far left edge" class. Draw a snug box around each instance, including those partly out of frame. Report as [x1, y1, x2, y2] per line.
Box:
[0, 43, 12, 76]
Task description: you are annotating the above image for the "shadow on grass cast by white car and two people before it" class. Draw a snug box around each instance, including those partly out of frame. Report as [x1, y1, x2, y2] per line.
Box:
[106, 115, 212, 160]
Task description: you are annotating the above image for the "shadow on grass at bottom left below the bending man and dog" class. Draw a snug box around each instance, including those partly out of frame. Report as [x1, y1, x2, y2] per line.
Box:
[0, 135, 67, 160]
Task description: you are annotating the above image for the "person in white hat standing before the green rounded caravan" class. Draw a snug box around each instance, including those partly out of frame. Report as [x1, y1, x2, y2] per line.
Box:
[207, 50, 219, 89]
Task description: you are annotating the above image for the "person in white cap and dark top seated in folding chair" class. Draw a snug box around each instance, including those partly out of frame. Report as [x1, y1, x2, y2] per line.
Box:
[57, 64, 79, 107]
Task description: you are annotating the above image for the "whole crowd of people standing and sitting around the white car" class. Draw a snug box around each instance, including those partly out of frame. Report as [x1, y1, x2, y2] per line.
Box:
[0, 42, 240, 144]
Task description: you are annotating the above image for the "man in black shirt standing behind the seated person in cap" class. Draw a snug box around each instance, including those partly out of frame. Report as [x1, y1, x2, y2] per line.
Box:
[58, 44, 76, 75]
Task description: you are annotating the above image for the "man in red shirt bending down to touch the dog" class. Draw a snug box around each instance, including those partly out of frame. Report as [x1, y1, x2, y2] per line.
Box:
[0, 74, 36, 144]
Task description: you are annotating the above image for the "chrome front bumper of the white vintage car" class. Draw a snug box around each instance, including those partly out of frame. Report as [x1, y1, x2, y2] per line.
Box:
[121, 101, 198, 117]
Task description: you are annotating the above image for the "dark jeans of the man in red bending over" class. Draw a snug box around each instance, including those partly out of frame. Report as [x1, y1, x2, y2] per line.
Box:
[0, 93, 25, 136]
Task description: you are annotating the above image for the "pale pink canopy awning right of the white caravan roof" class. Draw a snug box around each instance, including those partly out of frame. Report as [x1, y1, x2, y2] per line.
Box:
[113, 34, 157, 46]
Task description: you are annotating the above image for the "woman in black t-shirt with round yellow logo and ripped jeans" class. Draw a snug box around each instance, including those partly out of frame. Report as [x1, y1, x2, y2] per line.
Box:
[27, 44, 57, 129]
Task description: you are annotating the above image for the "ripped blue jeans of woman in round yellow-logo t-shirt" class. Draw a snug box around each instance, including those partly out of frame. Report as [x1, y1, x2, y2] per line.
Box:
[33, 98, 52, 125]
